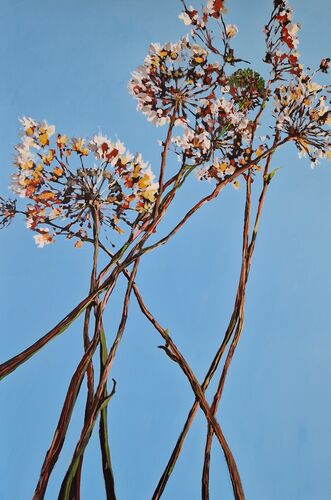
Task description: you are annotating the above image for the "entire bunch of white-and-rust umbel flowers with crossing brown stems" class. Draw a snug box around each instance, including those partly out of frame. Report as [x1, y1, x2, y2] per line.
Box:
[0, 0, 331, 500]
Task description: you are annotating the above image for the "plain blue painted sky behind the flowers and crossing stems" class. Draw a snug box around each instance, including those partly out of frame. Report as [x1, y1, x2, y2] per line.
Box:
[0, 0, 331, 500]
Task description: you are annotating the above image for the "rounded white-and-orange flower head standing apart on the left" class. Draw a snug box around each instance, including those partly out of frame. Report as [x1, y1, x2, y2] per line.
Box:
[3, 117, 158, 247]
